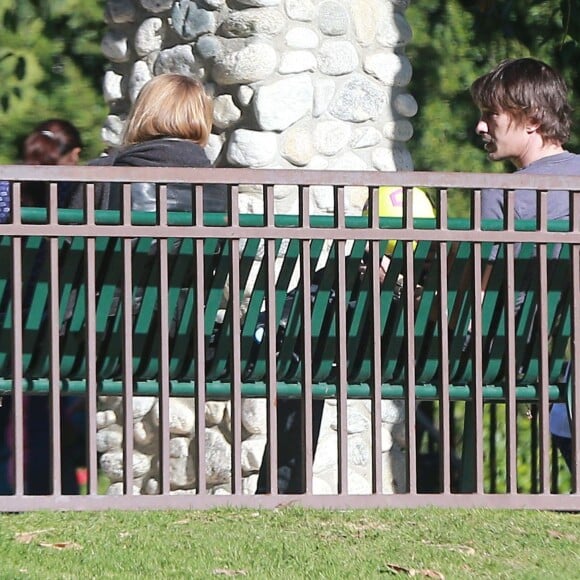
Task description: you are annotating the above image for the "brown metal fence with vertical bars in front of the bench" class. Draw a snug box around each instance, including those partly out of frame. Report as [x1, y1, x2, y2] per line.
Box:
[0, 166, 580, 511]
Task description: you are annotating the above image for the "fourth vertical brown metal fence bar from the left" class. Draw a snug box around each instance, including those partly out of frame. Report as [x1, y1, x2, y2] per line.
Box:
[121, 183, 134, 496]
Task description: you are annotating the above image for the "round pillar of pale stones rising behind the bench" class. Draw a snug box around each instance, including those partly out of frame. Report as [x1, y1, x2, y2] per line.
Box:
[96, 0, 417, 491]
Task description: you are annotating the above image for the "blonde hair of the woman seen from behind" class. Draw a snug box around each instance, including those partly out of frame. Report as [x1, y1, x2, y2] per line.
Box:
[123, 73, 213, 146]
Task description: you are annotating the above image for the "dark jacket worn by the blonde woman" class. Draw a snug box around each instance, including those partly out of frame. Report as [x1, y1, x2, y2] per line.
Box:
[69, 138, 227, 212]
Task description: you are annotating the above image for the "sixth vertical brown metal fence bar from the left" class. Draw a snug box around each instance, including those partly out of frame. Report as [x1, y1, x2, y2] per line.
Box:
[193, 185, 207, 496]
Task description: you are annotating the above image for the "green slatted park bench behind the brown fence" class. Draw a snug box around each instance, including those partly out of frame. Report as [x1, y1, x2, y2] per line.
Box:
[0, 209, 573, 498]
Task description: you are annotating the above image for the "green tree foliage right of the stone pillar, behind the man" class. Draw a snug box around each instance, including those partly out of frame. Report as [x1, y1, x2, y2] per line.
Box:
[407, 0, 580, 214]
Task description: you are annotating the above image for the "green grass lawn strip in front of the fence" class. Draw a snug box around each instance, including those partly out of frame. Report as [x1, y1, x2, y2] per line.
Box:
[0, 508, 580, 580]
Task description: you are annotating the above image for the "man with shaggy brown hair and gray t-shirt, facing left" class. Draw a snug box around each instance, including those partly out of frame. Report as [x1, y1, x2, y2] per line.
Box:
[471, 58, 580, 467]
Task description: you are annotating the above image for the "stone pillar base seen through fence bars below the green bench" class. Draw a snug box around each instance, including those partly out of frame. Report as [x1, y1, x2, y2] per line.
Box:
[97, 397, 406, 494]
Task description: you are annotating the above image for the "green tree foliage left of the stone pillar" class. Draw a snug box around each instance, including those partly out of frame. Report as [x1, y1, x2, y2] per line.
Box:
[0, 0, 107, 163]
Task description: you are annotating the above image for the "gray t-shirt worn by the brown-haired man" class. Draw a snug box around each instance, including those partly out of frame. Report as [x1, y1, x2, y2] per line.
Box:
[481, 151, 580, 220]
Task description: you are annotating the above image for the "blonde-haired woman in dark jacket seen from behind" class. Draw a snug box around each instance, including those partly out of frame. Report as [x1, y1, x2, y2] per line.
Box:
[71, 73, 226, 212]
